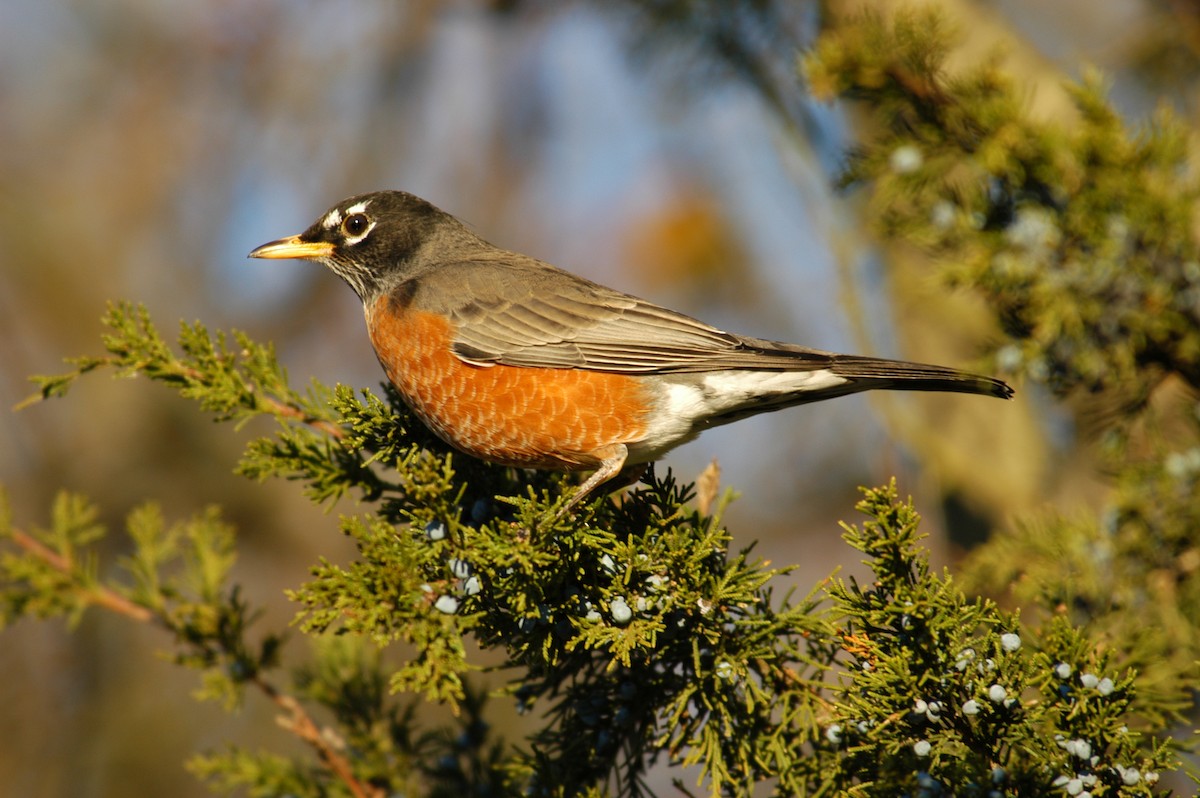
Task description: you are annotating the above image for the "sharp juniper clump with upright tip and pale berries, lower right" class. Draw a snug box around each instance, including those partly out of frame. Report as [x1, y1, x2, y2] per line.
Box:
[826, 485, 1170, 796]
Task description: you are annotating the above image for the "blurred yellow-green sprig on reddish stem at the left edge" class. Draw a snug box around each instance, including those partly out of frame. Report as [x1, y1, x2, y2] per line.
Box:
[0, 493, 283, 708]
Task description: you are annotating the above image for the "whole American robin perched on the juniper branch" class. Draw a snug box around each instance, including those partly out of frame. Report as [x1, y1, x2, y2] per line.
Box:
[250, 191, 1013, 508]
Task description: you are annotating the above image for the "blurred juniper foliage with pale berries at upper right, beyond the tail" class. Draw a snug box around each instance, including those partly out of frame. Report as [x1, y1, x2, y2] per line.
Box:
[804, 8, 1200, 402]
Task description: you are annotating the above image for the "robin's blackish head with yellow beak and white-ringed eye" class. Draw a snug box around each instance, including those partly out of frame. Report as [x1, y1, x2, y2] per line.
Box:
[250, 191, 481, 302]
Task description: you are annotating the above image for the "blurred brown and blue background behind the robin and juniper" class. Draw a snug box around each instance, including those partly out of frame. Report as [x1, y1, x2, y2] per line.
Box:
[0, 0, 1200, 796]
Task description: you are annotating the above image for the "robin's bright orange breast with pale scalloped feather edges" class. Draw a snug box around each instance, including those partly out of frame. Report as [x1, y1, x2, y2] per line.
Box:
[367, 298, 650, 470]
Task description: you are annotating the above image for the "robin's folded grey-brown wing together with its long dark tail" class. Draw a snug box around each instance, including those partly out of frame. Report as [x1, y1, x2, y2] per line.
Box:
[412, 251, 1013, 398]
